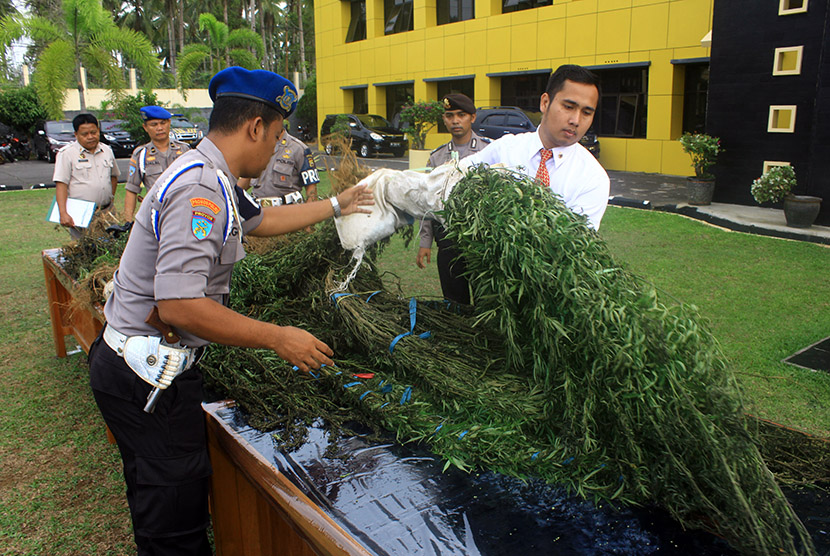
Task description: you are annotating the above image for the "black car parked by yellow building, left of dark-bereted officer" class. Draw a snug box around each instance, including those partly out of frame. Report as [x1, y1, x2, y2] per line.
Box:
[320, 114, 409, 158]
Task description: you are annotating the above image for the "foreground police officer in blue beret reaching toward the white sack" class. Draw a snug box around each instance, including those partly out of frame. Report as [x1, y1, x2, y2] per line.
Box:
[89, 67, 373, 556]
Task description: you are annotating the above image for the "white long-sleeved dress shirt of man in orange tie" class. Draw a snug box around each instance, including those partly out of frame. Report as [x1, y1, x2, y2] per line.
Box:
[464, 131, 611, 230]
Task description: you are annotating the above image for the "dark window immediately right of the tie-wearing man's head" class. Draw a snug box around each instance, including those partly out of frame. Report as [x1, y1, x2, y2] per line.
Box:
[592, 67, 648, 138]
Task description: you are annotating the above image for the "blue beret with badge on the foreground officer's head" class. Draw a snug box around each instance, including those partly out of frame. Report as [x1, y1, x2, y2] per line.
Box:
[208, 66, 297, 118]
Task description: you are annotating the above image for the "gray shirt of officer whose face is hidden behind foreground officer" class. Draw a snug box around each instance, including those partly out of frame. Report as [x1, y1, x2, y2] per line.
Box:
[251, 131, 320, 199]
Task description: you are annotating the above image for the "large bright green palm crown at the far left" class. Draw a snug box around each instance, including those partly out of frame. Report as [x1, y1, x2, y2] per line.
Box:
[0, 0, 161, 118]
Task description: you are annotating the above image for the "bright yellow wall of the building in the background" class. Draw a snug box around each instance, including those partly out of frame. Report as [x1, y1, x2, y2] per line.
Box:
[315, 0, 713, 175]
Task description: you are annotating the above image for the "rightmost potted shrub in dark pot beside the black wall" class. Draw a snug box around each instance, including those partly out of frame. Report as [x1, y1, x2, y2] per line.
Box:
[751, 166, 821, 228]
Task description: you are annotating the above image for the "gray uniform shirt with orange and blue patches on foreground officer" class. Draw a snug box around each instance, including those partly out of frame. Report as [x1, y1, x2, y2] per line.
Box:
[104, 138, 262, 347]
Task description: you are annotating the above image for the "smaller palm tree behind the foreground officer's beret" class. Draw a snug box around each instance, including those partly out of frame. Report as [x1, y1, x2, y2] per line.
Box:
[177, 13, 263, 91]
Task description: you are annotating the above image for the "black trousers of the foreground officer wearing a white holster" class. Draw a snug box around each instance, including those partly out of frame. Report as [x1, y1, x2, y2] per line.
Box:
[89, 336, 212, 556]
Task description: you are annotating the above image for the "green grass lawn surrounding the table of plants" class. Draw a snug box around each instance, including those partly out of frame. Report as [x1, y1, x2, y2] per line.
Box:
[0, 180, 830, 556]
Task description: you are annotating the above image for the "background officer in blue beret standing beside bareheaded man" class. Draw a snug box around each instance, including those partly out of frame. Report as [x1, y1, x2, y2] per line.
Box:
[124, 106, 190, 222]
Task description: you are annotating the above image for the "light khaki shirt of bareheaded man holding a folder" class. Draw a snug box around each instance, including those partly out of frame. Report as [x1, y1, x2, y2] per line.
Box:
[52, 141, 121, 207]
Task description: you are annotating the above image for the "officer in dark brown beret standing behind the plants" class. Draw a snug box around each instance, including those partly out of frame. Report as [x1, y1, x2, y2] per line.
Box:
[415, 93, 490, 304]
